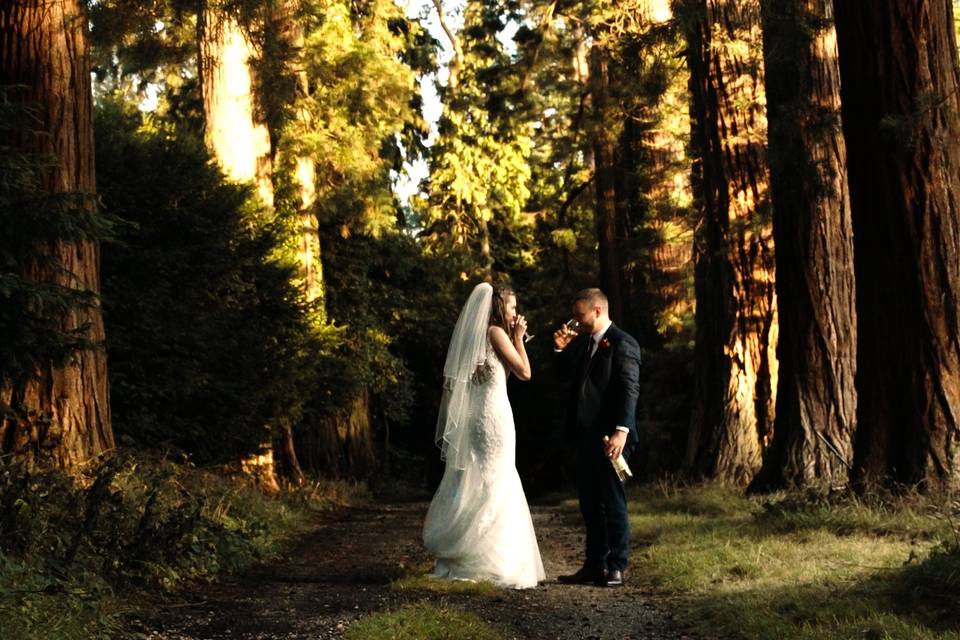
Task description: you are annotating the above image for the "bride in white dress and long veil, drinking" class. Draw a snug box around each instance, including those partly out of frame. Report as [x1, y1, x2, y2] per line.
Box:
[423, 283, 546, 589]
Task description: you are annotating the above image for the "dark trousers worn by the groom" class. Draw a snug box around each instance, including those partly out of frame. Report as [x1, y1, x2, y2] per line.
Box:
[577, 436, 630, 571]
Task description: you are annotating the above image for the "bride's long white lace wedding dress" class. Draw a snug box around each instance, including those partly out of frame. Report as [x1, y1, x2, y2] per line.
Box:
[423, 340, 546, 589]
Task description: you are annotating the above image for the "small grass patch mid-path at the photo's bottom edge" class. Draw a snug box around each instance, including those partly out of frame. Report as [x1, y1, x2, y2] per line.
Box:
[345, 602, 503, 640]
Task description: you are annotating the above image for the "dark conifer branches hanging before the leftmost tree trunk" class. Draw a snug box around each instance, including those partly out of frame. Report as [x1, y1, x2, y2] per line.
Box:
[0, 87, 115, 402]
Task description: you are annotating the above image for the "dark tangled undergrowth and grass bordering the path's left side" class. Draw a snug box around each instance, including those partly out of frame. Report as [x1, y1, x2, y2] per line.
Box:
[0, 454, 364, 640]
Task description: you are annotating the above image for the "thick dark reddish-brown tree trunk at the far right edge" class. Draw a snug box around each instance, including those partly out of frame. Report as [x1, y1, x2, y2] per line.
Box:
[835, 0, 960, 489]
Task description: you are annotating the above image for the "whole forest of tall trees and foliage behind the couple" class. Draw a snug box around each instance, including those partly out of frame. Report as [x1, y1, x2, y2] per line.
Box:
[0, 0, 960, 494]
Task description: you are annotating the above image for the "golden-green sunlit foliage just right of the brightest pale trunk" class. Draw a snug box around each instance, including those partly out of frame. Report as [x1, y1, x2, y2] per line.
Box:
[280, 0, 432, 235]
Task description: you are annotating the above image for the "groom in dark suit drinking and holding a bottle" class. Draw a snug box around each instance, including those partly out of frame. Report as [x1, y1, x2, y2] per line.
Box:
[553, 289, 640, 587]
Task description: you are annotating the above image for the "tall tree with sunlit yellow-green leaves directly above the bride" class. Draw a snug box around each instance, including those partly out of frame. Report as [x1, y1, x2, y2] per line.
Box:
[424, 0, 531, 278]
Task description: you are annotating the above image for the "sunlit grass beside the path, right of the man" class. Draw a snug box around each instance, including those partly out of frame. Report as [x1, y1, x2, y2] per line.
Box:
[631, 486, 960, 640]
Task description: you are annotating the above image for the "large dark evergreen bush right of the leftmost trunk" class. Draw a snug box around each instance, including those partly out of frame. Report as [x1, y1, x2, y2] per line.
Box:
[97, 104, 337, 462]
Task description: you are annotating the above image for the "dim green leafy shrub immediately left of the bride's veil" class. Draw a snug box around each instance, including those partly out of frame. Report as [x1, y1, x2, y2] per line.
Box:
[321, 219, 472, 450]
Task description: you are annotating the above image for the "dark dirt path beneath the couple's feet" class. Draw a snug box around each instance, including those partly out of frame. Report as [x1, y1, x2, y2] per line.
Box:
[125, 504, 692, 640]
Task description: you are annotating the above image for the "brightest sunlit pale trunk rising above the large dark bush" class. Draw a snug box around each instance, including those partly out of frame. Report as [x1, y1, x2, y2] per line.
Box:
[197, 3, 273, 207]
